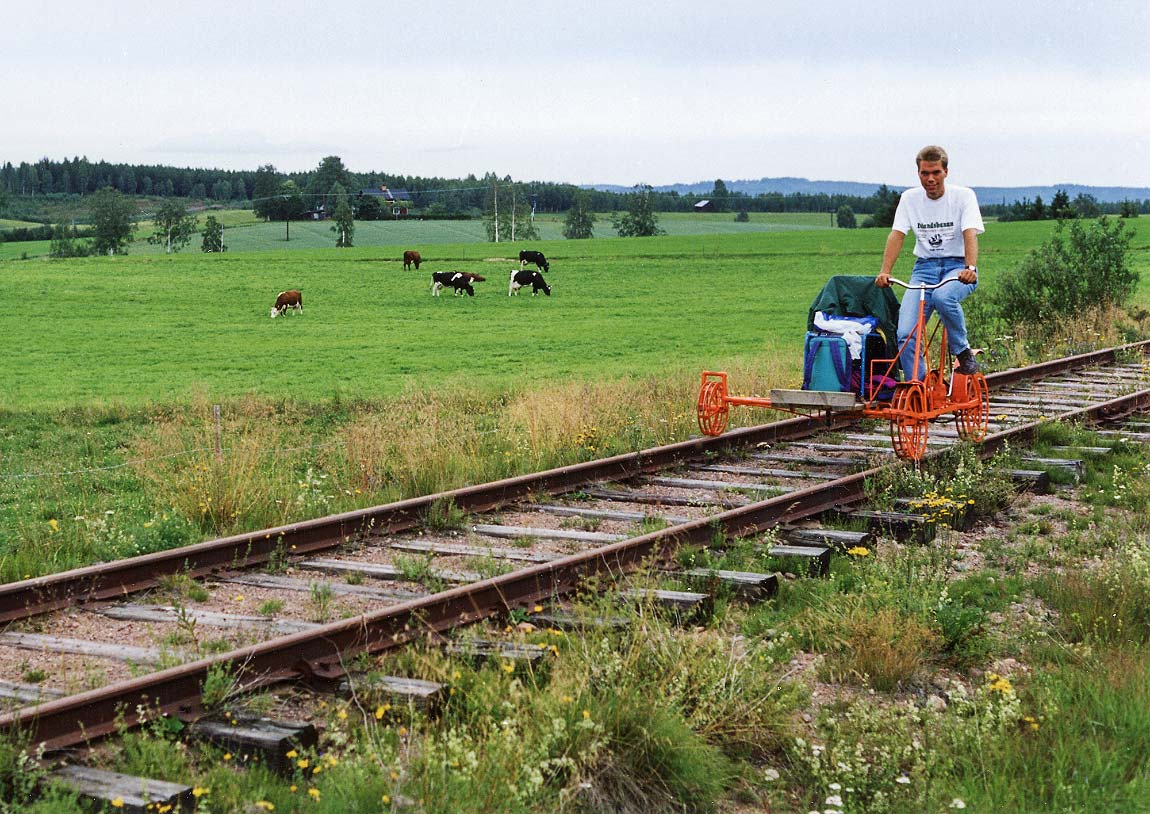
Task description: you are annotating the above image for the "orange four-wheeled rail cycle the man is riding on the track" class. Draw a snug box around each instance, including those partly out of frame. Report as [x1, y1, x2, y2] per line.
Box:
[696, 277, 990, 461]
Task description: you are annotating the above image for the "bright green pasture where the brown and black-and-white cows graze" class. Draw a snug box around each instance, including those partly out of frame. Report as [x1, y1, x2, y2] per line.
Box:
[0, 222, 1150, 408]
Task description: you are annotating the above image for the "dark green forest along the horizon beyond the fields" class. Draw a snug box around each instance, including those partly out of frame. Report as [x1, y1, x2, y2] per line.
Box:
[0, 156, 1150, 225]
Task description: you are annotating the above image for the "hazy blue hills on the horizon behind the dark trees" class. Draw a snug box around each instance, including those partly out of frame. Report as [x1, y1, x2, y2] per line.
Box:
[584, 177, 1150, 204]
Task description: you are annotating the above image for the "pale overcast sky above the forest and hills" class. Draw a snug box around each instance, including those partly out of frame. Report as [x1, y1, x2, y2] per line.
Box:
[0, 0, 1150, 186]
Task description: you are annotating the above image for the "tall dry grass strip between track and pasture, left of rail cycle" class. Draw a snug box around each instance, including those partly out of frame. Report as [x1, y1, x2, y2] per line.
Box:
[0, 363, 781, 581]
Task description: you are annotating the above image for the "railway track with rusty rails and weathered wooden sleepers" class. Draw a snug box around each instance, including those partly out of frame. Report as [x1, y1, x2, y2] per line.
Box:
[0, 343, 1150, 809]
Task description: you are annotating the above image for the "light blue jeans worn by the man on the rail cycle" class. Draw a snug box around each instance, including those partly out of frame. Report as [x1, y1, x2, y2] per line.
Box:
[898, 258, 979, 381]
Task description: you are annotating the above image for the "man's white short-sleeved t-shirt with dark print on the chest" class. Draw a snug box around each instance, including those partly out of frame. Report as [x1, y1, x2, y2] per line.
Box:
[892, 184, 986, 258]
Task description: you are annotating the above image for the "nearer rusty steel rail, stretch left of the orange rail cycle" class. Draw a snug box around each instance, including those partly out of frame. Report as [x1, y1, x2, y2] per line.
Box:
[0, 468, 880, 748]
